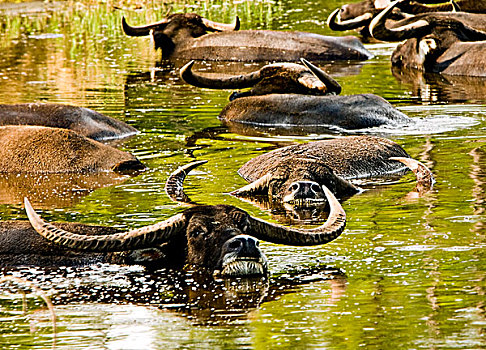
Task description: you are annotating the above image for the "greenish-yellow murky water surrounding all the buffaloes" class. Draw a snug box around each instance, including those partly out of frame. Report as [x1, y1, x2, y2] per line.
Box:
[0, 0, 486, 349]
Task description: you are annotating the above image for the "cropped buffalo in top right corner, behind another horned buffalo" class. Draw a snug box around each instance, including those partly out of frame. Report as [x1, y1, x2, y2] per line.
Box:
[327, 0, 486, 38]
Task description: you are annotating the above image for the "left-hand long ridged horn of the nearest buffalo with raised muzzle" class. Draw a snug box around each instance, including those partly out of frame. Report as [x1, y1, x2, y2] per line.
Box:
[24, 198, 186, 252]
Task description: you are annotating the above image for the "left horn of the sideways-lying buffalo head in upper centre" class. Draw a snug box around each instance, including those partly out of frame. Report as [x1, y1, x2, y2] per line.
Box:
[180, 60, 262, 89]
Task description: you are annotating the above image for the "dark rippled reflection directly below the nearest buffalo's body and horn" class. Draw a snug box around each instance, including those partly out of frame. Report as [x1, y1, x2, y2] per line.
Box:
[0, 265, 346, 325]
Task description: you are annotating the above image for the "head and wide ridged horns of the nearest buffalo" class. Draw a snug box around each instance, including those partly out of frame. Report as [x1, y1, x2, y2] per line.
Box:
[25, 162, 346, 276]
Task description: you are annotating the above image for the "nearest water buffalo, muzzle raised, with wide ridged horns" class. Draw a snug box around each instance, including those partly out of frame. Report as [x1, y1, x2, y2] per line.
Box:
[9, 162, 346, 276]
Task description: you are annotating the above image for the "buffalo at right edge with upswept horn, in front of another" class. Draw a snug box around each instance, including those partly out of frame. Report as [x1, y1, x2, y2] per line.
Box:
[370, 0, 486, 76]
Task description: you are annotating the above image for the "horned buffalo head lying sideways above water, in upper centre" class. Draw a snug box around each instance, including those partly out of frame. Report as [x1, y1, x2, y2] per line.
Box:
[180, 58, 341, 100]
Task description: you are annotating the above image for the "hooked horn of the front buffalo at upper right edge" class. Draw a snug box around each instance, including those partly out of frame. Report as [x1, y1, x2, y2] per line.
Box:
[369, 0, 430, 41]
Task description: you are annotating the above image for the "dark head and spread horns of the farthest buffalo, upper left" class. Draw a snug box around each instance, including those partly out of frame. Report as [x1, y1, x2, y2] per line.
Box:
[122, 13, 240, 56]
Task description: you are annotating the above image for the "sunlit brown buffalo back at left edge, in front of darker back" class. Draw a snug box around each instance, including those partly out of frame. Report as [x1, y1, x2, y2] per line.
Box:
[0, 125, 145, 173]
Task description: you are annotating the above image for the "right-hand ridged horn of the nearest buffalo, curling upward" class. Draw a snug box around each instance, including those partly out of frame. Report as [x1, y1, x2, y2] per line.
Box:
[250, 186, 346, 246]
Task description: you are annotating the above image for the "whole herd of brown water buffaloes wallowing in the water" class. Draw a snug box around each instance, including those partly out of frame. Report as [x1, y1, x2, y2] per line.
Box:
[0, 0, 486, 277]
